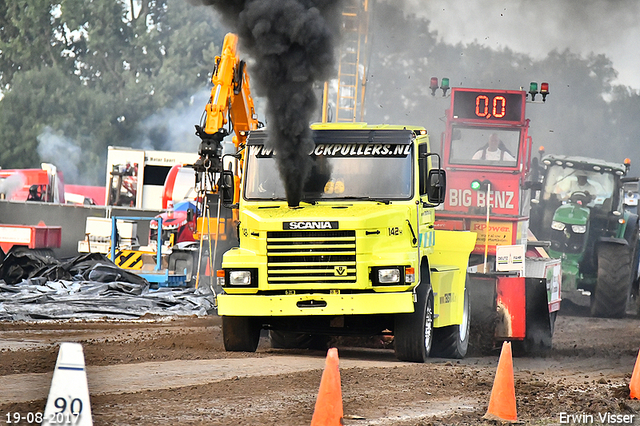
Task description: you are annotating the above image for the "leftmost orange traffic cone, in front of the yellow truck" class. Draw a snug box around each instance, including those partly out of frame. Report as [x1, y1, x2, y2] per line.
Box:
[311, 348, 343, 426]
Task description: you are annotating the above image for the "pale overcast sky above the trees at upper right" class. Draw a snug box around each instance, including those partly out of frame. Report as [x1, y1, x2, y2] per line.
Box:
[406, 0, 640, 90]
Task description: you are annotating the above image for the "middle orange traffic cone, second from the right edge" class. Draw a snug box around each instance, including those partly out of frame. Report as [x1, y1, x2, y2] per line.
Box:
[484, 342, 518, 422]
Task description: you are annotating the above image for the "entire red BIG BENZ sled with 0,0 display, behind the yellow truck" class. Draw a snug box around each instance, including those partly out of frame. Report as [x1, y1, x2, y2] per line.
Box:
[436, 83, 561, 352]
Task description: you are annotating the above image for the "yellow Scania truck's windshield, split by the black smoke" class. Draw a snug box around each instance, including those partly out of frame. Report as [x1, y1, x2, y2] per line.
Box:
[244, 144, 413, 201]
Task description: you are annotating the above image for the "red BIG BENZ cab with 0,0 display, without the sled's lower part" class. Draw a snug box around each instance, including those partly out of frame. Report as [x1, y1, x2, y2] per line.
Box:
[437, 88, 531, 251]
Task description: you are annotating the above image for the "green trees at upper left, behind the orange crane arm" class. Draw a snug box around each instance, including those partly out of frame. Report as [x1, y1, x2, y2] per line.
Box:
[0, 0, 225, 185]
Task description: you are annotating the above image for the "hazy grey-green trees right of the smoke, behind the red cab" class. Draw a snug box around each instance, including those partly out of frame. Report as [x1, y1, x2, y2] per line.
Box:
[366, 2, 640, 170]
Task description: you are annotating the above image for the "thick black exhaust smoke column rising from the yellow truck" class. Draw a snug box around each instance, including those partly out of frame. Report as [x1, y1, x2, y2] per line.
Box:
[195, 0, 343, 207]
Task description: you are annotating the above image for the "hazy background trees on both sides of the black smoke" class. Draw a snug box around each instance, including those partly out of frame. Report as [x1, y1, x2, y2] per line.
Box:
[0, 0, 640, 185]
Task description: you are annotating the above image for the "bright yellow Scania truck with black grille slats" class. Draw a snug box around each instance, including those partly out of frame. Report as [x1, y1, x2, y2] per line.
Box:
[217, 123, 476, 362]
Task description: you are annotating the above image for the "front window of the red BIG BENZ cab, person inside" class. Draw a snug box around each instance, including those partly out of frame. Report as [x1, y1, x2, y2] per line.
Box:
[449, 126, 520, 167]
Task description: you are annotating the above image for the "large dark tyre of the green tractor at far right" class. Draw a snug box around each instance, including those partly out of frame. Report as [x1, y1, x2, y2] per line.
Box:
[591, 244, 632, 318]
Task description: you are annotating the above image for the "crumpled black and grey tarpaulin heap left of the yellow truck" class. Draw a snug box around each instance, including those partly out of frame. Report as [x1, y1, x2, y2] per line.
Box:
[0, 253, 215, 320]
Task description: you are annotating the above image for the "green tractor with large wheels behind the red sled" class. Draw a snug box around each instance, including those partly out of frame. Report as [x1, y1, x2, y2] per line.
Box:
[530, 155, 639, 318]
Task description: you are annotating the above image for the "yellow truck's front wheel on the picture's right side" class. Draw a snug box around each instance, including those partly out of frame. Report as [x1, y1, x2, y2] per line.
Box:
[393, 269, 433, 362]
